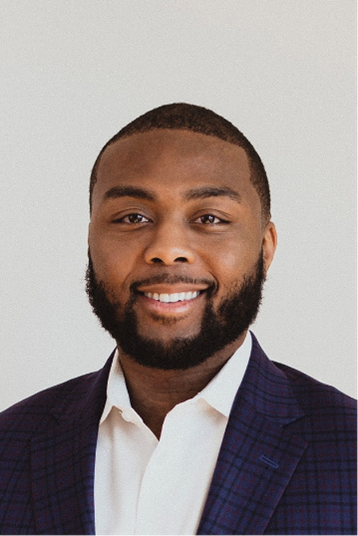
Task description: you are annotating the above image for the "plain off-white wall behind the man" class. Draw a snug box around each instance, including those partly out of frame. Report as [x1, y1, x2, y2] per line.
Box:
[0, 0, 357, 408]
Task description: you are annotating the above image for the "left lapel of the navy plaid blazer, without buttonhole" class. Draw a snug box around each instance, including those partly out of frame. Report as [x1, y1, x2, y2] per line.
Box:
[31, 354, 110, 536]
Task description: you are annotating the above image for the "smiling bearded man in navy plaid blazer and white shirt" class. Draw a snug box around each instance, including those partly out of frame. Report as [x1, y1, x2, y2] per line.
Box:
[0, 104, 358, 536]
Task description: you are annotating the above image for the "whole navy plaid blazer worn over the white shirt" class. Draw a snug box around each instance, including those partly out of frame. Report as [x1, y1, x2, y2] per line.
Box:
[0, 339, 358, 536]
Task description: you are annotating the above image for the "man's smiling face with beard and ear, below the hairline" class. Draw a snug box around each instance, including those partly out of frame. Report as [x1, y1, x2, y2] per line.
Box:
[88, 130, 276, 368]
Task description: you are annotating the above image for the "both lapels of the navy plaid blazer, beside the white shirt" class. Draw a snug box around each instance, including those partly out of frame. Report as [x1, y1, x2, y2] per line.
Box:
[31, 337, 306, 536]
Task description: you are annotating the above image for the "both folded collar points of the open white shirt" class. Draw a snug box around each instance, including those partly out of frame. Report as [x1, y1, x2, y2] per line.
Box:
[100, 332, 252, 424]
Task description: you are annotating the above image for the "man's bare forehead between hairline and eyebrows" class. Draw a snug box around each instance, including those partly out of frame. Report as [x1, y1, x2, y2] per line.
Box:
[93, 129, 254, 201]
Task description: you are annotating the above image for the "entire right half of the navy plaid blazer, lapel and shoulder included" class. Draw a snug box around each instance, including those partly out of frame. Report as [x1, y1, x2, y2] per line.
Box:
[198, 340, 358, 536]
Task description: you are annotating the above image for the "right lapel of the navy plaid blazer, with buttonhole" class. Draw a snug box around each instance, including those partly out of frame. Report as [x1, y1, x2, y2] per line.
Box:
[197, 339, 306, 536]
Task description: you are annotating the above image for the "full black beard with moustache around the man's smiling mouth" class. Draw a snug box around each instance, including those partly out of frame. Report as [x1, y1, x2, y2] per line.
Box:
[86, 252, 265, 370]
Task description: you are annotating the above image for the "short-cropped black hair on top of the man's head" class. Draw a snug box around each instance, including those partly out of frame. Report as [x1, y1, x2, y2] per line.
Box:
[90, 103, 271, 220]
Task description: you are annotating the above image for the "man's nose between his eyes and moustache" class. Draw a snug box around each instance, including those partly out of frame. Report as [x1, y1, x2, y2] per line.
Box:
[145, 224, 195, 266]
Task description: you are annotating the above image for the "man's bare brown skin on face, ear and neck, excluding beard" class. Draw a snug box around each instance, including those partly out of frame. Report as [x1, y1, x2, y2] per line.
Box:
[89, 130, 277, 438]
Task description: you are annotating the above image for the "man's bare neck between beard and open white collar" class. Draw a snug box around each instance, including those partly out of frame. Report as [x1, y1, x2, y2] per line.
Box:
[119, 333, 246, 439]
